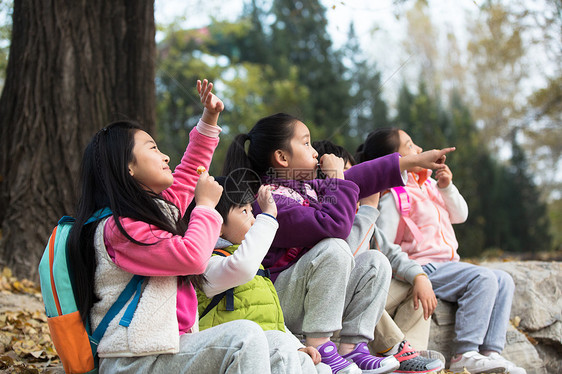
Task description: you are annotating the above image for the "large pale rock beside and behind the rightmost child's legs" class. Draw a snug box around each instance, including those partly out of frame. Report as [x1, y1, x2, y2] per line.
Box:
[429, 261, 562, 374]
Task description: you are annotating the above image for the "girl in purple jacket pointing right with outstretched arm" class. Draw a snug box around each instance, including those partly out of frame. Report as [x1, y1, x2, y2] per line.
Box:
[224, 113, 454, 373]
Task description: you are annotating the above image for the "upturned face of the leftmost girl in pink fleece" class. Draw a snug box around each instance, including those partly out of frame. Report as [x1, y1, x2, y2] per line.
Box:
[129, 130, 174, 193]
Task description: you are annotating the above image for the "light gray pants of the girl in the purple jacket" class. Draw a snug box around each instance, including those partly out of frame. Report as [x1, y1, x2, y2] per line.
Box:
[275, 239, 392, 343]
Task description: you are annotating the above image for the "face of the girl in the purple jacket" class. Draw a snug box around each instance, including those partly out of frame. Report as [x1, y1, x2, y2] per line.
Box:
[285, 121, 318, 180]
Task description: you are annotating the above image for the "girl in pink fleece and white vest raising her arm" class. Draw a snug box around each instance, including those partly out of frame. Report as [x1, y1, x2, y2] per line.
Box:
[68, 80, 282, 373]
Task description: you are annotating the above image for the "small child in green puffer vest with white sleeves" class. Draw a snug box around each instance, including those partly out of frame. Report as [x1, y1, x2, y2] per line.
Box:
[197, 173, 331, 373]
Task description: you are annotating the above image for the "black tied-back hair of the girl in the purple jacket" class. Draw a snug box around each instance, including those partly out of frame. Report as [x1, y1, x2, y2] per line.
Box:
[223, 113, 299, 177]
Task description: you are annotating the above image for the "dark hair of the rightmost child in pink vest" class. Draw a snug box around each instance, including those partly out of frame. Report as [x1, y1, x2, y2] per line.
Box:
[355, 127, 400, 162]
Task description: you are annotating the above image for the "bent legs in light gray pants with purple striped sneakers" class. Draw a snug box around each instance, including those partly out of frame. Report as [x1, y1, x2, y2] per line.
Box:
[275, 244, 399, 373]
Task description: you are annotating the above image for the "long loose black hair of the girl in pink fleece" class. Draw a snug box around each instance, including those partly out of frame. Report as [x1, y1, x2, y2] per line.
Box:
[67, 121, 197, 321]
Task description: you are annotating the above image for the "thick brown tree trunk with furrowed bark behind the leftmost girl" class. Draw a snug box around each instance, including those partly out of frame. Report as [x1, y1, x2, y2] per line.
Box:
[0, 0, 156, 280]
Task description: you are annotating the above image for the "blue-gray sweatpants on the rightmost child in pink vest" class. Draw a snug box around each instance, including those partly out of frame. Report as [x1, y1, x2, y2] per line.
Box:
[423, 262, 515, 353]
